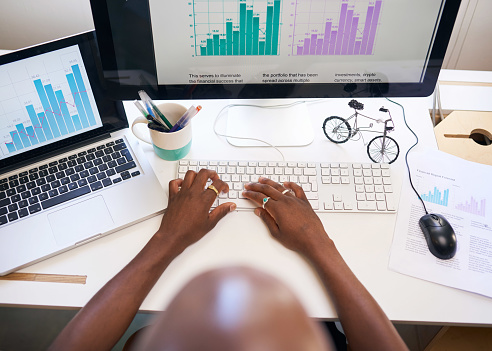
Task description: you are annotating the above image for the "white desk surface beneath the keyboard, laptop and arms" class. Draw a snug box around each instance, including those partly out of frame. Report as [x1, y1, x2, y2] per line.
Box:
[0, 98, 492, 325]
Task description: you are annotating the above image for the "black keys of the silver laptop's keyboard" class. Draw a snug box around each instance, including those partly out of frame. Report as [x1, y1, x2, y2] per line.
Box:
[0, 139, 140, 226]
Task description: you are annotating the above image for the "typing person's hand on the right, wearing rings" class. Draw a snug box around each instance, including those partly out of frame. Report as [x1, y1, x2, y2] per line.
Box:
[243, 177, 330, 256]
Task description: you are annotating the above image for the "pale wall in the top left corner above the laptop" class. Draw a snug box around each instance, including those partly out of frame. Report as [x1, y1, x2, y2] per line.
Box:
[0, 0, 94, 50]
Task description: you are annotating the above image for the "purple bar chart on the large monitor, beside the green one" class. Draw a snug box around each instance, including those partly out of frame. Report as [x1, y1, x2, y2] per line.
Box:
[292, 0, 383, 56]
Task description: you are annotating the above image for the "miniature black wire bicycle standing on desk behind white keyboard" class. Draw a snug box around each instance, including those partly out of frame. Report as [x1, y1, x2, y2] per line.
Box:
[323, 100, 400, 163]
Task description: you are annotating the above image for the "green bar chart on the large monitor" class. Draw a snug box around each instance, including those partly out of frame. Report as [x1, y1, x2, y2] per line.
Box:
[193, 0, 282, 57]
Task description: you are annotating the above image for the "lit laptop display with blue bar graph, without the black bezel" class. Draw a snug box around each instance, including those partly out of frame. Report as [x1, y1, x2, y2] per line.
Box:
[0, 45, 102, 159]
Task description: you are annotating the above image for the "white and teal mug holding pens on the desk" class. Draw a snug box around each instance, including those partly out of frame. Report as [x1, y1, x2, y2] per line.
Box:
[132, 103, 192, 161]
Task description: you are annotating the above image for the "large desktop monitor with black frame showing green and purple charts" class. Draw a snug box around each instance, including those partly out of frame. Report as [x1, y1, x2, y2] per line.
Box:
[91, 0, 460, 99]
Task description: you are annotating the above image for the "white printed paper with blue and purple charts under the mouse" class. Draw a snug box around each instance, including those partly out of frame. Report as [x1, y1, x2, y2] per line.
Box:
[389, 151, 492, 297]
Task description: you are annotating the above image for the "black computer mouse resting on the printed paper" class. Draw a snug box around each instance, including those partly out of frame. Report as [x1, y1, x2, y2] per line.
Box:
[419, 213, 456, 260]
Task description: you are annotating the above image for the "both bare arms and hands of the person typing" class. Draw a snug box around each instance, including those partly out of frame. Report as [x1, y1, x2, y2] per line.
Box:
[50, 170, 407, 351]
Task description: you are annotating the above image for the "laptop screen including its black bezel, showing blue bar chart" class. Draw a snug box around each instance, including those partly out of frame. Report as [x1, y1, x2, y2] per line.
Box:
[0, 31, 128, 173]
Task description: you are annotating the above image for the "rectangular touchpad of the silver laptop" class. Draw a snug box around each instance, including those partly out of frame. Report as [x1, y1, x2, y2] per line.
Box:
[48, 196, 113, 246]
